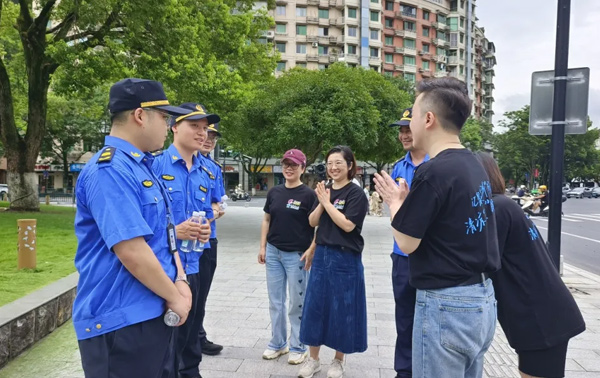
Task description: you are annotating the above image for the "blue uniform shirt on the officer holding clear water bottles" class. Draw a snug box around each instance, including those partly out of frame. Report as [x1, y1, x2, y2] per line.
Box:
[152, 145, 212, 274]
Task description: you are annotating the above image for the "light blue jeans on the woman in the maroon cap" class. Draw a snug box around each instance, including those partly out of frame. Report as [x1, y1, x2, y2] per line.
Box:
[265, 243, 308, 353]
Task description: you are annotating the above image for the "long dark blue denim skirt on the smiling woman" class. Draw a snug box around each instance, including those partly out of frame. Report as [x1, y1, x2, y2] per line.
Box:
[300, 245, 367, 353]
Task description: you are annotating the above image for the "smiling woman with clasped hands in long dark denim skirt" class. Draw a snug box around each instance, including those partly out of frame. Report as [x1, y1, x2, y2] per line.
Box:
[298, 146, 369, 378]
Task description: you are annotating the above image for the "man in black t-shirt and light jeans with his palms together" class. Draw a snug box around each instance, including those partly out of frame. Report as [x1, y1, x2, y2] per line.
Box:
[375, 77, 500, 378]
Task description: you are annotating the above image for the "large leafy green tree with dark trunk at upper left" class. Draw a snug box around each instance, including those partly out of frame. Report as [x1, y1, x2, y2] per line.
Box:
[0, 0, 276, 210]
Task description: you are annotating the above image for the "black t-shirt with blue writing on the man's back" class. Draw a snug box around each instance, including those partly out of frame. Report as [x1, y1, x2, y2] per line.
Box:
[392, 149, 500, 290]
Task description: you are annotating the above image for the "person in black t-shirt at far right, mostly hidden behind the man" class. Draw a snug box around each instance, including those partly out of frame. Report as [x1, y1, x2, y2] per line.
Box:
[479, 153, 585, 378]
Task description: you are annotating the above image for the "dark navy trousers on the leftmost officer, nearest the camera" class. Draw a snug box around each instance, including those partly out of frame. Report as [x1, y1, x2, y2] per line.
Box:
[79, 316, 175, 378]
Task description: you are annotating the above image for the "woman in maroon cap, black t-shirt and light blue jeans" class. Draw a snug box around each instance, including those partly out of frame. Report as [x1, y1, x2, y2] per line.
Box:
[258, 149, 317, 365]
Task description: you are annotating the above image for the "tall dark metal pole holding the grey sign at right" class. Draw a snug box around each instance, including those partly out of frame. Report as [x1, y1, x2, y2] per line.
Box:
[548, 0, 571, 271]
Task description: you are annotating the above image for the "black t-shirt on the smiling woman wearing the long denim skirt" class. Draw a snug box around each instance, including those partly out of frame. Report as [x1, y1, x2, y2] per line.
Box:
[313, 182, 369, 253]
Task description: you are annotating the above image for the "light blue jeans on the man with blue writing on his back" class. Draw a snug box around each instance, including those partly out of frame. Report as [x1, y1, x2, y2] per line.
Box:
[413, 279, 496, 378]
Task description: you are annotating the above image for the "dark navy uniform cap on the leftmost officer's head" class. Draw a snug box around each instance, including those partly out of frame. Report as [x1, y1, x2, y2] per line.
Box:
[108, 78, 189, 116]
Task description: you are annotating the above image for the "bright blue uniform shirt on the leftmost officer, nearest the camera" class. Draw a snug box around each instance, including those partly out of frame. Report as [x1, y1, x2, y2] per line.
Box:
[73, 136, 177, 340]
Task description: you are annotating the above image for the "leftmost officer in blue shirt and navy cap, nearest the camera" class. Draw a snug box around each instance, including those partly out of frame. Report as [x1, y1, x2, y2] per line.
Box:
[73, 79, 210, 377]
